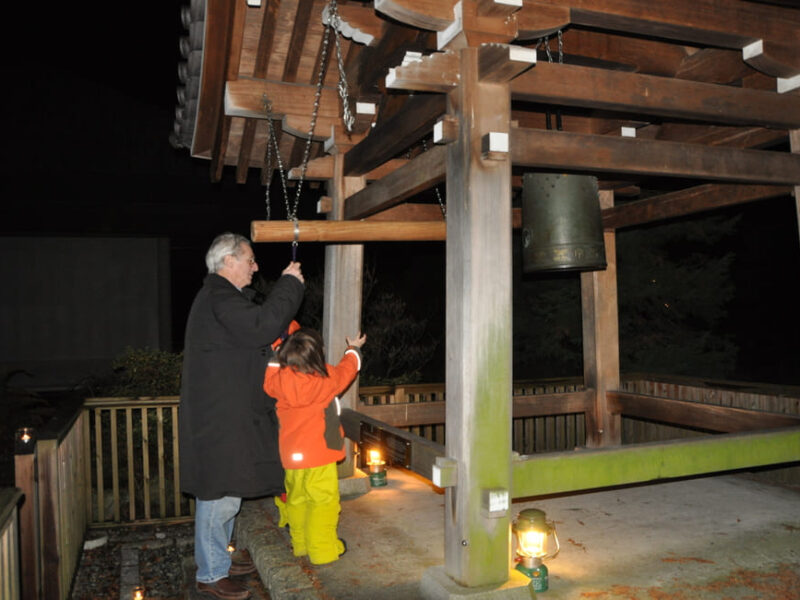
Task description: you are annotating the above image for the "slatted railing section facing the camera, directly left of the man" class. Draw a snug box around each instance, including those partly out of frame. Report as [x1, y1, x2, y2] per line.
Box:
[84, 396, 194, 526]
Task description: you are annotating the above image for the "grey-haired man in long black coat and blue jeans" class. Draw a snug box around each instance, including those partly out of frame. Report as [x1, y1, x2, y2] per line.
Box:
[180, 233, 304, 600]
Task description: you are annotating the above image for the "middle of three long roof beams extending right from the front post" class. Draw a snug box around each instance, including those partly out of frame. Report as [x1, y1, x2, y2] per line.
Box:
[511, 63, 800, 129]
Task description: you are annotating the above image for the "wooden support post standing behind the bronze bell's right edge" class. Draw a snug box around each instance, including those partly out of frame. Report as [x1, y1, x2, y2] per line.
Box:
[581, 191, 622, 447]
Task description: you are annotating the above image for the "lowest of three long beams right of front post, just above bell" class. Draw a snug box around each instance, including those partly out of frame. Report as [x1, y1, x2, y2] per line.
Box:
[509, 127, 800, 185]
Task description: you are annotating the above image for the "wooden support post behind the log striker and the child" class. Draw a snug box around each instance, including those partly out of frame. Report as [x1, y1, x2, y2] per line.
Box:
[322, 153, 369, 478]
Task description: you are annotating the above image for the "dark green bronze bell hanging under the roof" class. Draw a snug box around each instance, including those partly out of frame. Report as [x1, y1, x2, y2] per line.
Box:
[522, 173, 606, 273]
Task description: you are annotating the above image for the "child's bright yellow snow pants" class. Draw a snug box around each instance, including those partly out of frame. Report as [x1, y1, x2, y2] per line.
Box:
[286, 463, 344, 565]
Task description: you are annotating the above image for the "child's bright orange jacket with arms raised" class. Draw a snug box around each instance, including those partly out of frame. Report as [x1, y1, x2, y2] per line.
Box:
[264, 348, 361, 469]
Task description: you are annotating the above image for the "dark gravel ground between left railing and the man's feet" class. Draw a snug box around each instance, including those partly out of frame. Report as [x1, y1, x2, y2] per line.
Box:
[70, 523, 269, 600]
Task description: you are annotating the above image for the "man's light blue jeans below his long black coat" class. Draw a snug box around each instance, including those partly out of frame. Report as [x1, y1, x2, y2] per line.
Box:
[194, 496, 242, 583]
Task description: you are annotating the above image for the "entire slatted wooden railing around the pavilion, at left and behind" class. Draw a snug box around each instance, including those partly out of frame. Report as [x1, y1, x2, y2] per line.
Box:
[10, 376, 800, 600]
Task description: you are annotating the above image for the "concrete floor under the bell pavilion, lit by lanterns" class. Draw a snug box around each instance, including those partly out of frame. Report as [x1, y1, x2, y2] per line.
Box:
[236, 468, 800, 600]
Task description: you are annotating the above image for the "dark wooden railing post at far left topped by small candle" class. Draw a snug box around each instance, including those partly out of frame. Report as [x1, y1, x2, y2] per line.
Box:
[14, 428, 41, 600]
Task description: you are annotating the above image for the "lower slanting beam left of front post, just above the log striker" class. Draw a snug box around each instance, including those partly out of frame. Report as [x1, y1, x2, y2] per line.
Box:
[344, 146, 447, 219]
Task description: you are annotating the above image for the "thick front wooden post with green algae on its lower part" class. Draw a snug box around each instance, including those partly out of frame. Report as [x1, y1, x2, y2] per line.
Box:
[445, 48, 512, 587]
